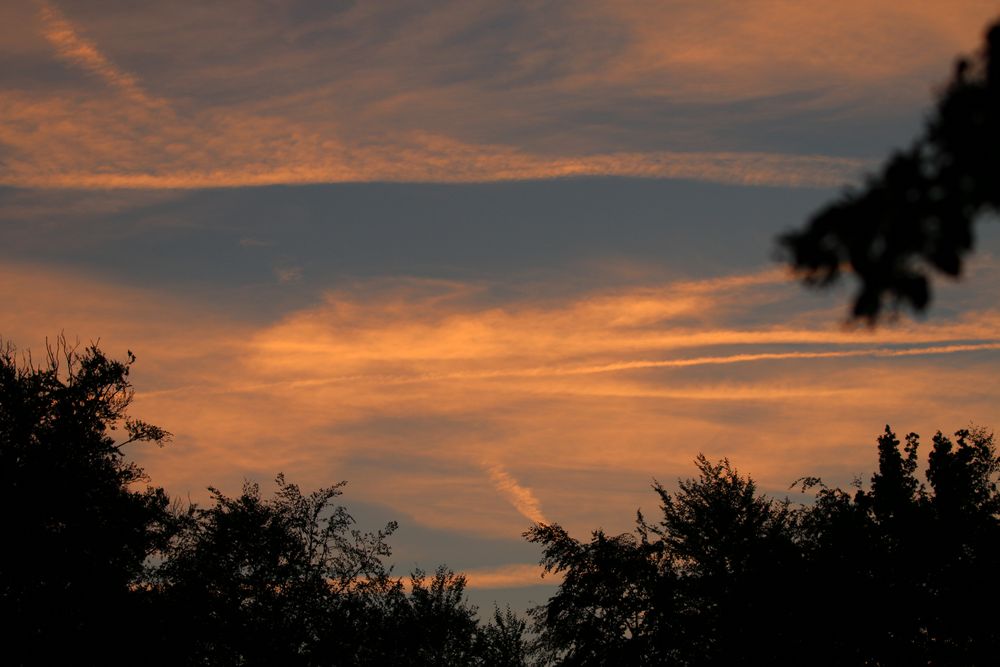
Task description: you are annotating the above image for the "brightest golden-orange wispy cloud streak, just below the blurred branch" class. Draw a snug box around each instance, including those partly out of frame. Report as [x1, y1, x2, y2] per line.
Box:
[240, 271, 1000, 383]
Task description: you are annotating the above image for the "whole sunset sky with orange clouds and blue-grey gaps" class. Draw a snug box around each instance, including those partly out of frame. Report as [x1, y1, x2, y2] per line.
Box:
[0, 0, 1000, 611]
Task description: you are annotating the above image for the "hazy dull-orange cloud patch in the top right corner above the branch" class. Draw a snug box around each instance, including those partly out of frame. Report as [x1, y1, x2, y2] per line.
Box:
[602, 0, 997, 105]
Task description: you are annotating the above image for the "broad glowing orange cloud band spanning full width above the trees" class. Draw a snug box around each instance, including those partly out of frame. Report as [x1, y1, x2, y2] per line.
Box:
[0, 258, 1000, 537]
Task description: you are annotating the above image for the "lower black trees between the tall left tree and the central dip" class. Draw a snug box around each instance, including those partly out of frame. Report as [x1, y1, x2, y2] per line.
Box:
[151, 475, 508, 665]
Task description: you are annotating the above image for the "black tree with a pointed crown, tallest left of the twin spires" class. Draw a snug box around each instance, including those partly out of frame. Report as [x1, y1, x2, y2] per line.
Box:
[640, 455, 801, 665]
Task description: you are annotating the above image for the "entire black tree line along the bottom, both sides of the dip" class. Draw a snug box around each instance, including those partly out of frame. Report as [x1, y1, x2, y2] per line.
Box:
[0, 342, 1000, 665]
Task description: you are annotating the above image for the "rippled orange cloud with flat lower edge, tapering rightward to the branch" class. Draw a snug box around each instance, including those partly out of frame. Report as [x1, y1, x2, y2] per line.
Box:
[0, 87, 867, 189]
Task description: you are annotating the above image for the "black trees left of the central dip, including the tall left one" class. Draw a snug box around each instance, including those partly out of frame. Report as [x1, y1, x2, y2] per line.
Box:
[0, 339, 526, 666]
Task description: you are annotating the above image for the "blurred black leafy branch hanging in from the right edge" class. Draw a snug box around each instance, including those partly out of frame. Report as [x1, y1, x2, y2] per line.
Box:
[780, 15, 1000, 322]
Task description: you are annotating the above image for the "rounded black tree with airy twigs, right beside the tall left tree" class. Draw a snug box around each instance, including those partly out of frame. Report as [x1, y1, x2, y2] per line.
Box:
[150, 475, 395, 665]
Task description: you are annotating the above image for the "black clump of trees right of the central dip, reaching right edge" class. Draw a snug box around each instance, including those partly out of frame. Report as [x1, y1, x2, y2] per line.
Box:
[526, 427, 1000, 665]
